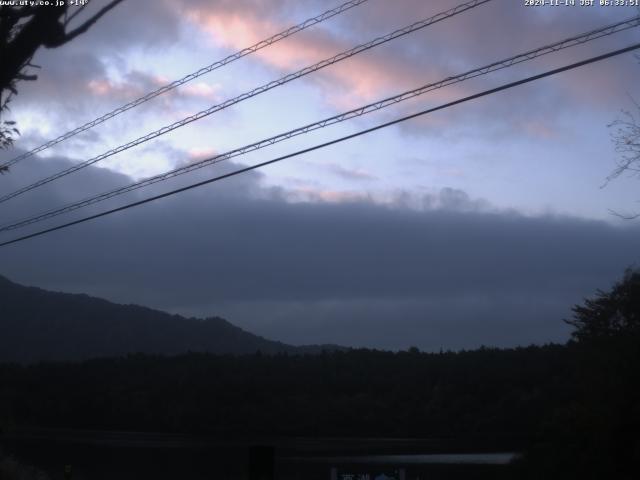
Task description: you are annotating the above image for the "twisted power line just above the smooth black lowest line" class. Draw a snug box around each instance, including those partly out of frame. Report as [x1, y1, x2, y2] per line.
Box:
[0, 16, 640, 232]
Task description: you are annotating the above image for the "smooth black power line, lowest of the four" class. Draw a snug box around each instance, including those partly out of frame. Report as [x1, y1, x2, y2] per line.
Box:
[0, 43, 640, 247]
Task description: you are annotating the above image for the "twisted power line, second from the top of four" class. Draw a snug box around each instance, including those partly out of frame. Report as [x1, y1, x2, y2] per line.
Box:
[0, 0, 492, 203]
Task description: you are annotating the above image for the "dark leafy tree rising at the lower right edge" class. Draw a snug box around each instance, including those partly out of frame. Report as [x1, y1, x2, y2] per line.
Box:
[522, 269, 640, 480]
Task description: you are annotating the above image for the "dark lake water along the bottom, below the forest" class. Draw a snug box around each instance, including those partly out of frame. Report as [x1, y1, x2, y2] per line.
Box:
[2, 429, 515, 480]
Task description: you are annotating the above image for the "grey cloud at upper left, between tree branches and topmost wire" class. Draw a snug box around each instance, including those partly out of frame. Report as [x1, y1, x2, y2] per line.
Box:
[8, 0, 181, 127]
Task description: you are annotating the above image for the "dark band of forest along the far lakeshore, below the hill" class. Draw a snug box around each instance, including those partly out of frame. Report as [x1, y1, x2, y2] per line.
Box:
[0, 346, 567, 442]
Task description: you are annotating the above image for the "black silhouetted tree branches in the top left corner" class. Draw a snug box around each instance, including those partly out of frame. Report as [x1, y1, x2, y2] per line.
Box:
[0, 0, 123, 158]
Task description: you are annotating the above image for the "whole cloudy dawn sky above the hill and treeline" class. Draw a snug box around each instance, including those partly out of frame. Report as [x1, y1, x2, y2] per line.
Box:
[0, 0, 640, 351]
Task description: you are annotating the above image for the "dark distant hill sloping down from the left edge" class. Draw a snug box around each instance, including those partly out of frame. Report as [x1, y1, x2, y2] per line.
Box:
[0, 276, 337, 362]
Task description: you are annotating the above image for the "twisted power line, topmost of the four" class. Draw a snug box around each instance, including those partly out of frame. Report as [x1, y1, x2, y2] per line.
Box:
[0, 0, 369, 171]
